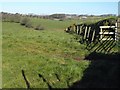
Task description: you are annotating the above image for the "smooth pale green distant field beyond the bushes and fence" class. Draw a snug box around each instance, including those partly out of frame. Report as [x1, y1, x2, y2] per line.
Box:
[31, 18, 104, 30]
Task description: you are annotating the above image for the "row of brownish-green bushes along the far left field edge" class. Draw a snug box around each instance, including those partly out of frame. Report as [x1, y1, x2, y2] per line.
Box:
[0, 12, 44, 30]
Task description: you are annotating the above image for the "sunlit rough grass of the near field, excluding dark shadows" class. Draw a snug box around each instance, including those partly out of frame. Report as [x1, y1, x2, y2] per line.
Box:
[2, 22, 89, 88]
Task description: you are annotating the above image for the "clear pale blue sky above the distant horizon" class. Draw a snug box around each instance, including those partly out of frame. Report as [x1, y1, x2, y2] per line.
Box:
[0, 2, 118, 15]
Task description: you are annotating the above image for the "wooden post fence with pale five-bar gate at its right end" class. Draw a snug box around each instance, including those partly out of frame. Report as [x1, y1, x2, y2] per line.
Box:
[65, 20, 117, 42]
